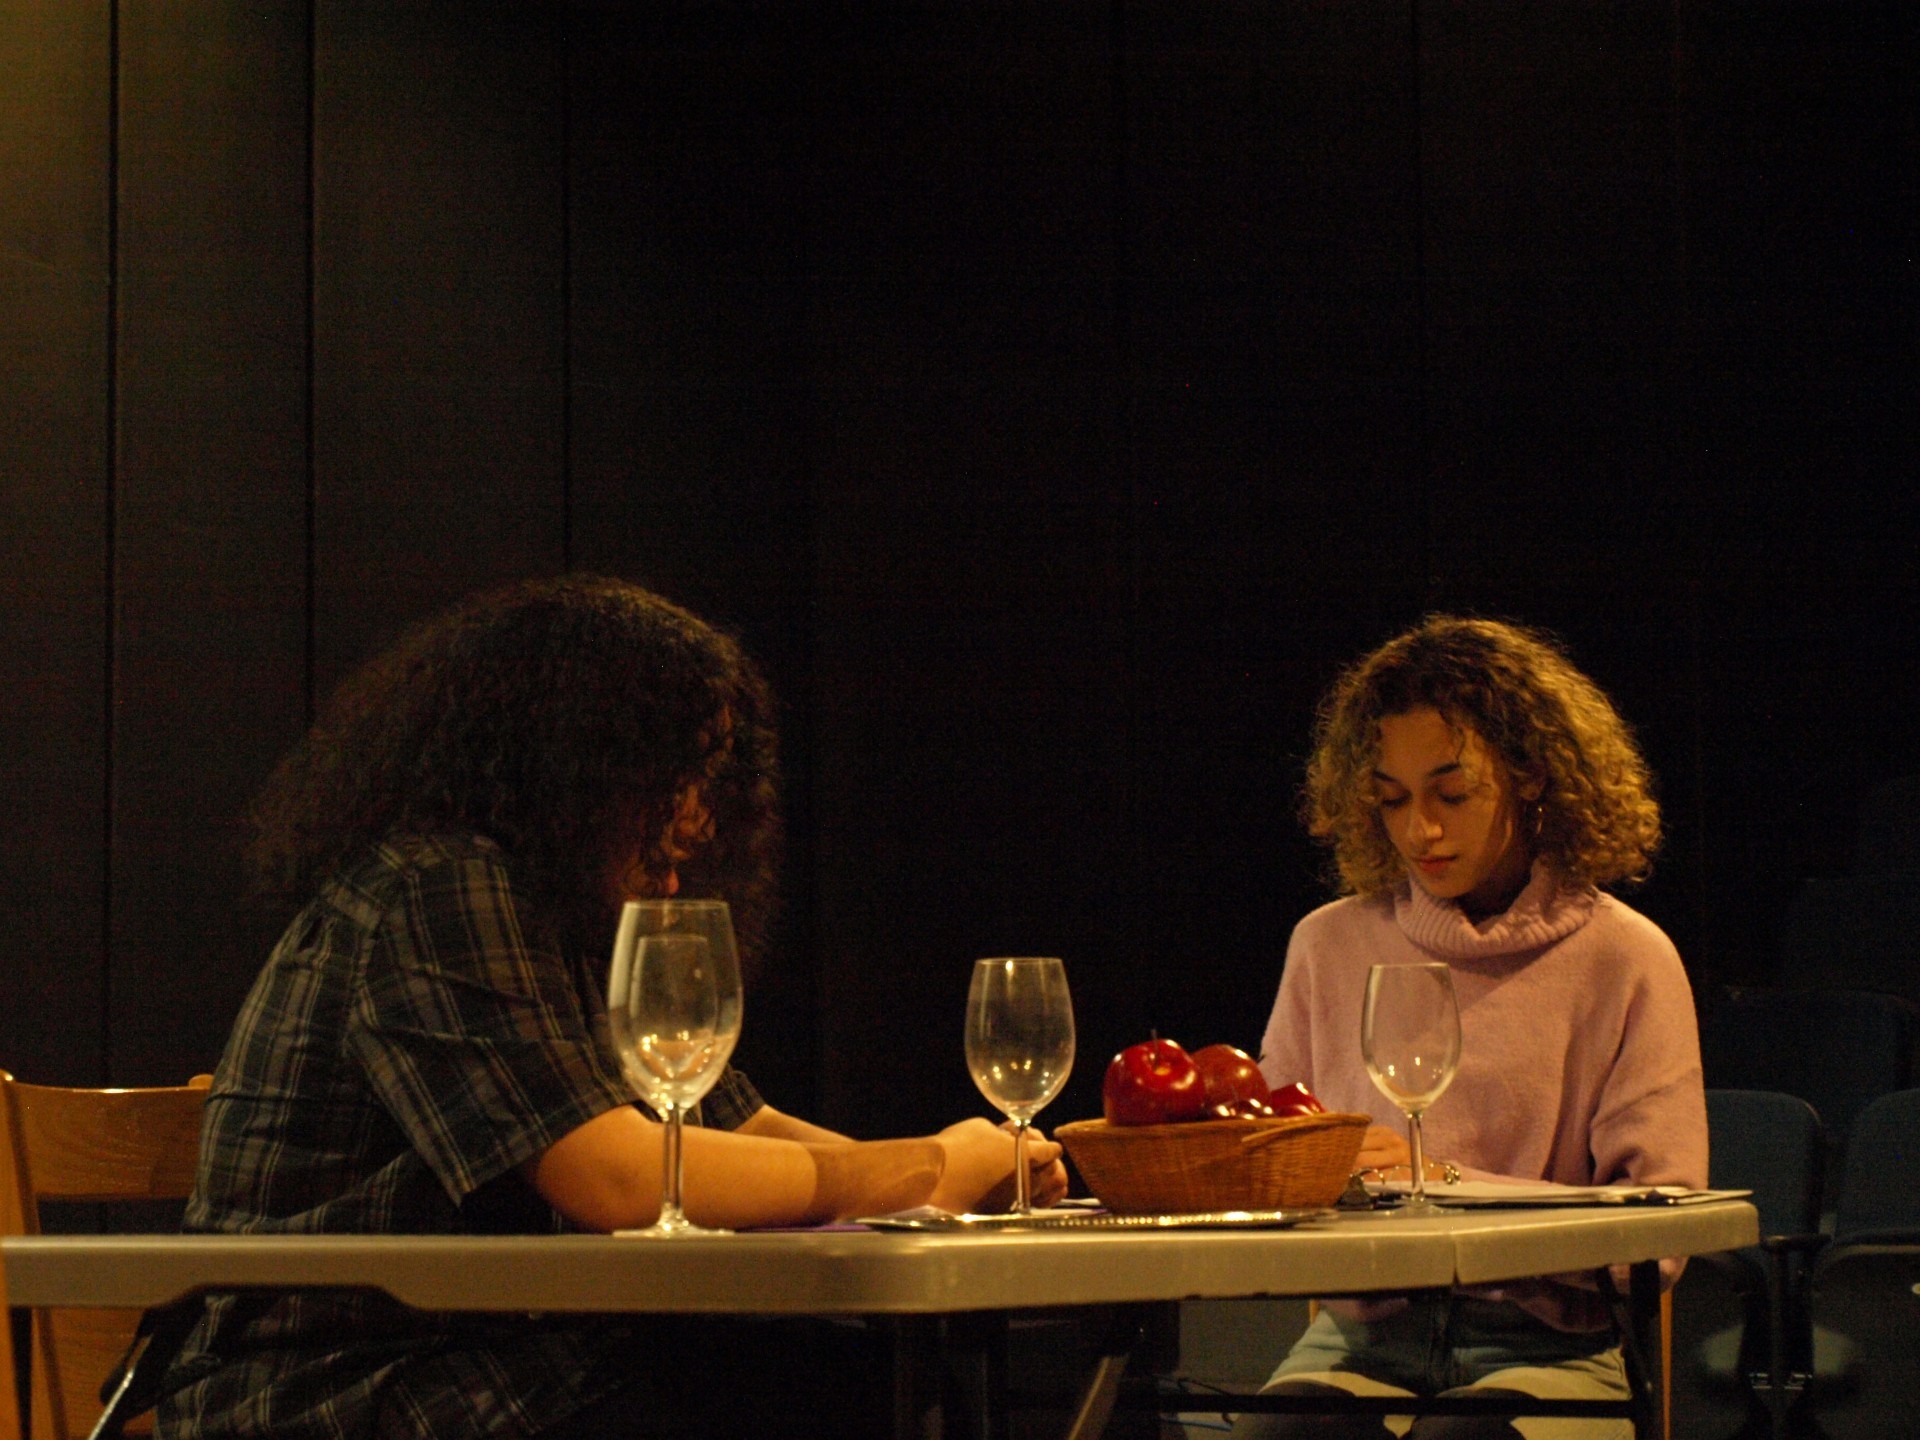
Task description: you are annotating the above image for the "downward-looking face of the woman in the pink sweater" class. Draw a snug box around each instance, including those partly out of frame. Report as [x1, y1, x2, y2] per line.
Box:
[1373, 708, 1534, 922]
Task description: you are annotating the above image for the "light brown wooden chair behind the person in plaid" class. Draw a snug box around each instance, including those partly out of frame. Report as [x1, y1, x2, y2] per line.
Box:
[0, 1069, 213, 1440]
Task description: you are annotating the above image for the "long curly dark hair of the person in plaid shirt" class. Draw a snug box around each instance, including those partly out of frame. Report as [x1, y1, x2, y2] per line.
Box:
[248, 574, 780, 971]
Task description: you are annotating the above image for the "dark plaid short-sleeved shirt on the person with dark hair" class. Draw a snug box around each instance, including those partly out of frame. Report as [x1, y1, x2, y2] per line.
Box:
[159, 837, 760, 1440]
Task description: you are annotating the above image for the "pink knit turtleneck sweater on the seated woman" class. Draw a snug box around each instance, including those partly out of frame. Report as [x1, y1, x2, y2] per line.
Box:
[1260, 862, 1707, 1329]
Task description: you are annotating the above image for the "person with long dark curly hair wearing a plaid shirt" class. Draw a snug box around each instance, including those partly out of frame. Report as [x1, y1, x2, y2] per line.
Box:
[157, 576, 1066, 1440]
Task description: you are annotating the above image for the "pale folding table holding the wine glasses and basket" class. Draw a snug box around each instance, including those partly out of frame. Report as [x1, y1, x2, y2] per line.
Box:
[0, 1200, 1759, 1432]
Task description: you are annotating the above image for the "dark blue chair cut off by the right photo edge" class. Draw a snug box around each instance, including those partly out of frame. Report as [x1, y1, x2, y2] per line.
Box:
[1805, 1091, 1920, 1440]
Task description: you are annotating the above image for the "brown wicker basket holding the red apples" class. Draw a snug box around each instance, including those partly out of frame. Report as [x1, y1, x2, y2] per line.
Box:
[1054, 1114, 1371, 1215]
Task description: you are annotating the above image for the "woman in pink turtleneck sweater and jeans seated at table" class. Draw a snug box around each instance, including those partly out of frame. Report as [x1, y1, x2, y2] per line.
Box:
[1236, 616, 1707, 1440]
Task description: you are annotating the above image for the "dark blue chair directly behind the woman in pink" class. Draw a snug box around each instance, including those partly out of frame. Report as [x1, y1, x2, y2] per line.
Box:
[1670, 1091, 1824, 1440]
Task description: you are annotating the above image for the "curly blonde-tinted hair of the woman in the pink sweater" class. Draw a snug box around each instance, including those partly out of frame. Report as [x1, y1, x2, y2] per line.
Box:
[1300, 614, 1661, 895]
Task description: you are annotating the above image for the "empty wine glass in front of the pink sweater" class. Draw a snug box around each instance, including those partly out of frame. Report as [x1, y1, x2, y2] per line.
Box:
[1359, 964, 1459, 1213]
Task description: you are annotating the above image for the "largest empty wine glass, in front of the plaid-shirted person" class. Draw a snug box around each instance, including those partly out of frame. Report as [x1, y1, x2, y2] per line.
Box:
[607, 900, 741, 1236]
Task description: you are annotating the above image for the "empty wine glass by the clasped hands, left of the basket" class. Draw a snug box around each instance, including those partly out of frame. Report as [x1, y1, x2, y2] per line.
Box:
[966, 956, 1073, 1215]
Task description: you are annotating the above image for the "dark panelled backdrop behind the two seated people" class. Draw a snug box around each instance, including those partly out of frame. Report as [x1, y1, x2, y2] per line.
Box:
[0, 0, 1920, 1133]
